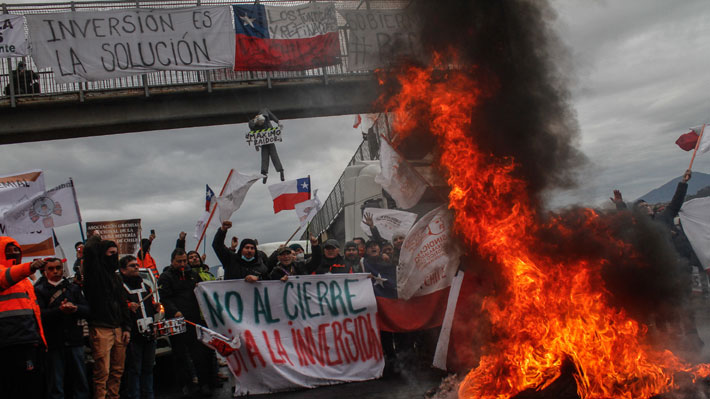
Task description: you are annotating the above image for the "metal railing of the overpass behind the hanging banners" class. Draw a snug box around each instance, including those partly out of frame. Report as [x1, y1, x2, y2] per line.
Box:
[0, 0, 409, 107]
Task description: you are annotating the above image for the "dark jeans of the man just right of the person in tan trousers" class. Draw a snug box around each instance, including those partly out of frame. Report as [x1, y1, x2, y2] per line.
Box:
[124, 334, 155, 399]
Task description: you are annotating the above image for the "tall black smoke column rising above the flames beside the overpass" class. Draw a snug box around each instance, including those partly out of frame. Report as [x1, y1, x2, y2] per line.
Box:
[411, 0, 586, 208]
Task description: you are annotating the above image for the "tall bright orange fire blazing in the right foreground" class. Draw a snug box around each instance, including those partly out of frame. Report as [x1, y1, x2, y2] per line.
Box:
[384, 57, 708, 399]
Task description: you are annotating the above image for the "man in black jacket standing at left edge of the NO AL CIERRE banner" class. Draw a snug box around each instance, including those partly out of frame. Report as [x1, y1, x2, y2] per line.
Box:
[158, 248, 216, 395]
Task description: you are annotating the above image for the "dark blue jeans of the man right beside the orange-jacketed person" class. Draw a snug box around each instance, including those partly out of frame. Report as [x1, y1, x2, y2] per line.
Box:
[47, 346, 89, 399]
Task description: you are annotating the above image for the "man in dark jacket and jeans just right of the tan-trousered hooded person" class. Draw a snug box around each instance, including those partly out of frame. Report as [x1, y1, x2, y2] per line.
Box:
[119, 255, 160, 399]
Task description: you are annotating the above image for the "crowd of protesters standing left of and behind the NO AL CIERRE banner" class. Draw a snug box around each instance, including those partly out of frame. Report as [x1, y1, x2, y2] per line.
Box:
[0, 214, 418, 399]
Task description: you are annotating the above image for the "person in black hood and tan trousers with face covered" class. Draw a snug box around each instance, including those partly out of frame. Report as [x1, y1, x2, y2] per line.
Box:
[84, 234, 131, 399]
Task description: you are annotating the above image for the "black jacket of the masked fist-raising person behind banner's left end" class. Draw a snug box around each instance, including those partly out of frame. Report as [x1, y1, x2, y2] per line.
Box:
[212, 229, 269, 280]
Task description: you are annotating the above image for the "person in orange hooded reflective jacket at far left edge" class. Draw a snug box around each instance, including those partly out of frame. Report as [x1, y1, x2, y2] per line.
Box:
[0, 237, 47, 398]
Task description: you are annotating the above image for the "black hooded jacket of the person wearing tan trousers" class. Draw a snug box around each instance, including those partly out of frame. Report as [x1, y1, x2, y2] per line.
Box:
[84, 236, 131, 331]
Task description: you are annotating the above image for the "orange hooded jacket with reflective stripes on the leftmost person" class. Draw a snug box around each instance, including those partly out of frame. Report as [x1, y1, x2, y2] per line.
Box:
[0, 237, 47, 348]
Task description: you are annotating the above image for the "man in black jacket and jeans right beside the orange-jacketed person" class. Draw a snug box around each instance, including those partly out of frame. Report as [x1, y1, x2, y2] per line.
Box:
[35, 258, 89, 399]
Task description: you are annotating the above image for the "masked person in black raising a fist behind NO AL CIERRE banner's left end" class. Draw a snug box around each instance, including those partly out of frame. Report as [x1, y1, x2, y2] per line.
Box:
[212, 220, 269, 282]
